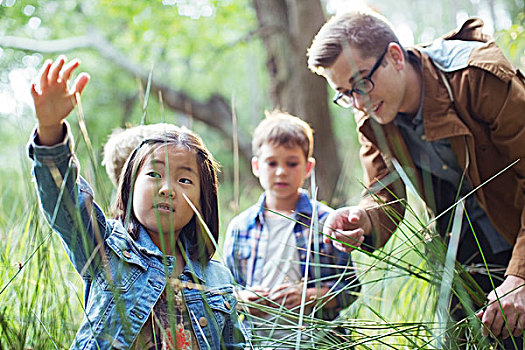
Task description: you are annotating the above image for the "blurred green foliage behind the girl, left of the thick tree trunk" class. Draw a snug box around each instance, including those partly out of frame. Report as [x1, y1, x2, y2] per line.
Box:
[0, 0, 270, 232]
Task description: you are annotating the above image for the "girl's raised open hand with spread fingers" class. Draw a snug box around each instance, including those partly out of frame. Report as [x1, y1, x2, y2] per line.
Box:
[31, 56, 89, 146]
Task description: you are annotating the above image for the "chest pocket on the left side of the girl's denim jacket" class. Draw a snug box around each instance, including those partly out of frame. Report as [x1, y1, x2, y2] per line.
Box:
[95, 236, 147, 293]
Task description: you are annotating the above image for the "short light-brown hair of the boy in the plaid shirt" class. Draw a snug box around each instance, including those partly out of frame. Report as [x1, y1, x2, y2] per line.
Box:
[252, 110, 314, 159]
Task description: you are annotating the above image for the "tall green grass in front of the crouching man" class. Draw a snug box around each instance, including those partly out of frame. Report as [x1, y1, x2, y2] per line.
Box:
[237, 189, 500, 349]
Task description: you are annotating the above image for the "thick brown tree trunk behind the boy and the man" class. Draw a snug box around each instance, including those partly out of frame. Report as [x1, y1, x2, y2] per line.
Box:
[254, 0, 341, 201]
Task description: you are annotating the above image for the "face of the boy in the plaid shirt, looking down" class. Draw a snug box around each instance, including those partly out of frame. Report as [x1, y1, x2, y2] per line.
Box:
[252, 143, 314, 200]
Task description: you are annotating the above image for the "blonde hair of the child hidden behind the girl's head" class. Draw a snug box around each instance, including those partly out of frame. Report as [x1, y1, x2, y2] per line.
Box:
[102, 123, 180, 186]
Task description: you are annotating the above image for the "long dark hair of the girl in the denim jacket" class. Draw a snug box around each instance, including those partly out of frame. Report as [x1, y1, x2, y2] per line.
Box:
[114, 128, 219, 260]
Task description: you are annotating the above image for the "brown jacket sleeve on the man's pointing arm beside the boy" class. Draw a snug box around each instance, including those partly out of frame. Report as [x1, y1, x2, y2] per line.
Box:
[356, 116, 405, 250]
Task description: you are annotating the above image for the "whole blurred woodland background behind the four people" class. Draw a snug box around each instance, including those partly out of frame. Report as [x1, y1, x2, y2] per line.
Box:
[0, 0, 525, 349]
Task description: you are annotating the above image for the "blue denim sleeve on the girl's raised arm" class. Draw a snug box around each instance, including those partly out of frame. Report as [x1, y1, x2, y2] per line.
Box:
[28, 124, 106, 277]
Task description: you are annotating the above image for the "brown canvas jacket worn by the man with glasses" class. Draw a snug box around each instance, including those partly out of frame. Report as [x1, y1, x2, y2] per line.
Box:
[356, 19, 525, 278]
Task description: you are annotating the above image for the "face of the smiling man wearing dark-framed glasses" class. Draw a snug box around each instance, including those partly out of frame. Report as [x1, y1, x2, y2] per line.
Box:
[325, 44, 406, 124]
